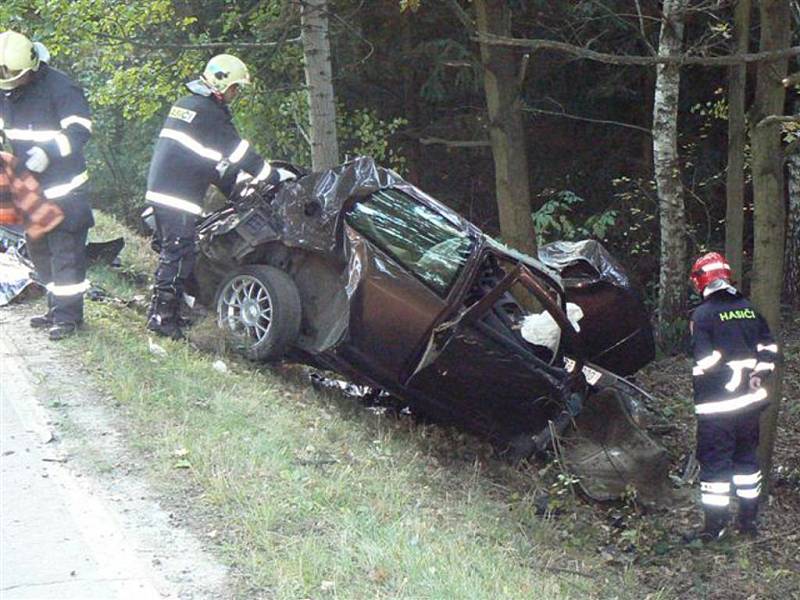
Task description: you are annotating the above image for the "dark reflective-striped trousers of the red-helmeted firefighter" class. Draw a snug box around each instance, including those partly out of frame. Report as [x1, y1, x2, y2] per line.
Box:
[697, 407, 763, 514]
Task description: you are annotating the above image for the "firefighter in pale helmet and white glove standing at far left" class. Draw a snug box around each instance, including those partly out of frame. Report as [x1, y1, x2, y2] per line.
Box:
[0, 31, 94, 340]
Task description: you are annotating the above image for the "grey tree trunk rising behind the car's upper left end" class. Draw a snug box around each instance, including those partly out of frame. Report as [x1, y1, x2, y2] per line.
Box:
[300, 0, 339, 171]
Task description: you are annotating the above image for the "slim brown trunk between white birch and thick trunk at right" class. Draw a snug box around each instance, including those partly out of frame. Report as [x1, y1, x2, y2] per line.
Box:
[725, 0, 751, 285]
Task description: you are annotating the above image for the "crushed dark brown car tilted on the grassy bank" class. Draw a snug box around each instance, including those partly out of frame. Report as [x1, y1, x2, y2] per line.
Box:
[188, 158, 668, 501]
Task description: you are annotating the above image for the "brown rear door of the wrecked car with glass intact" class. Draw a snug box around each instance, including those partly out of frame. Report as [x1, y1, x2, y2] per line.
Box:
[342, 189, 474, 387]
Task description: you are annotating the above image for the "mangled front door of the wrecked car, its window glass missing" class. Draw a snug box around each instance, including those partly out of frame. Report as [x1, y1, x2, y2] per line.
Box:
[406, 252, 580, 440]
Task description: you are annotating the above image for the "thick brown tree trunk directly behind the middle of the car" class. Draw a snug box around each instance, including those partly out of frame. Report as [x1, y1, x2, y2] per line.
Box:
[475, 0, 536, 256]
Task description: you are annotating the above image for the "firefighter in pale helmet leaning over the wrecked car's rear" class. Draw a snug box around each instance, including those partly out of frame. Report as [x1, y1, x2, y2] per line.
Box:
[146, 54, 279, 338]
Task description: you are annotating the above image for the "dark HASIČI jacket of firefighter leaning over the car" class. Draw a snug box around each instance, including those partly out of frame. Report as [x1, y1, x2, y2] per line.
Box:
[146, 81, 277, 215]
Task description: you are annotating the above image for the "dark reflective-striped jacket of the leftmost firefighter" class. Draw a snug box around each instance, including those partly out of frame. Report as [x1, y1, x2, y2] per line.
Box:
[0, 63, 93, 231]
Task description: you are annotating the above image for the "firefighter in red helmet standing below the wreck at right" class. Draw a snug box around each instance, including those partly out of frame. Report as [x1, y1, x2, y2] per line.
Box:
[691, 252, 778, 541]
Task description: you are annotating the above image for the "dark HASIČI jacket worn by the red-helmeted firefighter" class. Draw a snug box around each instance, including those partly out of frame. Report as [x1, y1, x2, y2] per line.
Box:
[692, 287, 778, 418]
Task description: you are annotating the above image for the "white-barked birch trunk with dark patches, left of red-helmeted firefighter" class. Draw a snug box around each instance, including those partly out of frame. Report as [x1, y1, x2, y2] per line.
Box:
[653, 0, 687, 331]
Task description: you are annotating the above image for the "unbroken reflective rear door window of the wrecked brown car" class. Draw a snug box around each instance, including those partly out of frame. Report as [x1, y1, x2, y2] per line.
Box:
[346, 189, 473, 296]
